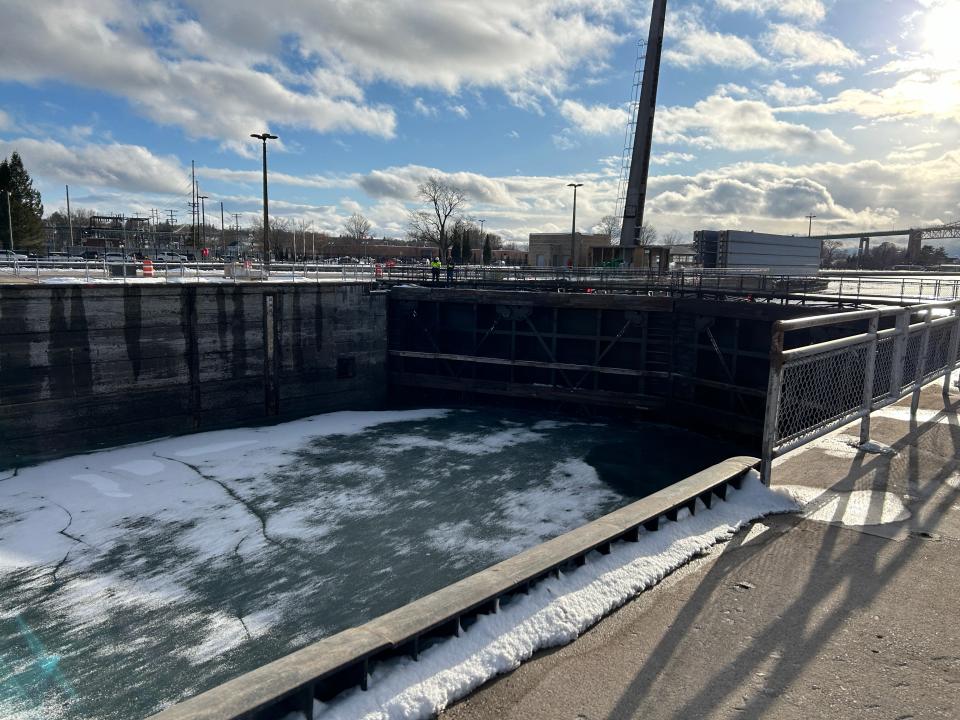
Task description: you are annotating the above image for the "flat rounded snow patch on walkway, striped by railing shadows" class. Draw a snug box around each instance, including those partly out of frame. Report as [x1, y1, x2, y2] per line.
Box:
[777, 485, 910, 527]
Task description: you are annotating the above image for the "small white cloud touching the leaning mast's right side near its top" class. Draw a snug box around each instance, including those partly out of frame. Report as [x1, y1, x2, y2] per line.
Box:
[663, 10, 765, 68]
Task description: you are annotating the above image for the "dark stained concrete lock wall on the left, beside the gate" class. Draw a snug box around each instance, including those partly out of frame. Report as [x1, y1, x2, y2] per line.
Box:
[0, 284, 387, 467]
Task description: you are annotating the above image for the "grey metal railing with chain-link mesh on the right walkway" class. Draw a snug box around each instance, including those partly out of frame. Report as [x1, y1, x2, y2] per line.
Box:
[761, 301, 960, 484]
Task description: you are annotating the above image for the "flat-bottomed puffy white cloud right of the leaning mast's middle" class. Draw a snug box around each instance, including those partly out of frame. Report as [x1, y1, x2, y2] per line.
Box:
[654, 94, 852, 155]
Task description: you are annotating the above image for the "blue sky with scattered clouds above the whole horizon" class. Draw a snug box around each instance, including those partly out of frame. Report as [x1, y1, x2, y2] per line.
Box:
[0, 0, 960, 249]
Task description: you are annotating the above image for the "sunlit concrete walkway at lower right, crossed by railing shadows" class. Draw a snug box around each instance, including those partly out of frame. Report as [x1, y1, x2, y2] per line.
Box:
[442, 384, 960, 720]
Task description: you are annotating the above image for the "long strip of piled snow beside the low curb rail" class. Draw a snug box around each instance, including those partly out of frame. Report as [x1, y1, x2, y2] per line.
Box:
[278, 471, 796, 720]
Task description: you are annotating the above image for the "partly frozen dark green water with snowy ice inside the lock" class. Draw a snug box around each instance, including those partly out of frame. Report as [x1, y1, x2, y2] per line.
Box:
[0, 410, 737, 720]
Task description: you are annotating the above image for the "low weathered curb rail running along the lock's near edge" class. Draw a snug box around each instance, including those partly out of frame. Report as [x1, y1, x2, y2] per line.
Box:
[151, 457, 759, 720]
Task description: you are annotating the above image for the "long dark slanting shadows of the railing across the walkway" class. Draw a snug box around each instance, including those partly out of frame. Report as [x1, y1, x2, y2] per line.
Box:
[609, 390, 960, 720]
